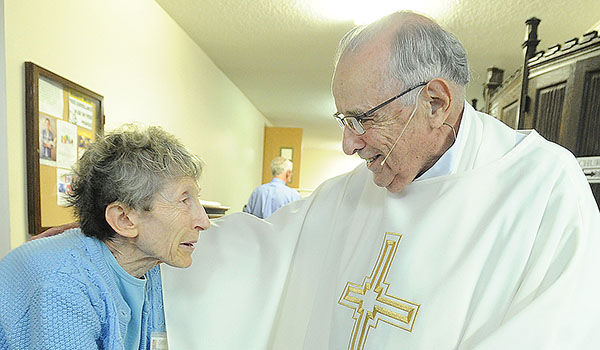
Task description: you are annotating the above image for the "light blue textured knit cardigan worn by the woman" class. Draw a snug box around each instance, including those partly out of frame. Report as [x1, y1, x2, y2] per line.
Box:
[0, 229, 165, 350]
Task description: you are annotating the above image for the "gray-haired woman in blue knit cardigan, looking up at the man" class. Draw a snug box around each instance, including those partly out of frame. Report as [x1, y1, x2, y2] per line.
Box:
[0, 126, 210, 349]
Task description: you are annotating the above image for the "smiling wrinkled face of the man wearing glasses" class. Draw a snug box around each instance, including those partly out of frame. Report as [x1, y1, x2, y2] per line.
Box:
[333, 47, 439, 192]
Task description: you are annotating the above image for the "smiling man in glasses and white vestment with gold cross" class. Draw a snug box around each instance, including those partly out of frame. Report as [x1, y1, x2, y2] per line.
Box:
[164, 12, 600, 349]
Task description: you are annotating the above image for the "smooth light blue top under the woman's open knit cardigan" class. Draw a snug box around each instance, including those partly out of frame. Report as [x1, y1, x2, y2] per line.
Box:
[102, 244, 146, 349]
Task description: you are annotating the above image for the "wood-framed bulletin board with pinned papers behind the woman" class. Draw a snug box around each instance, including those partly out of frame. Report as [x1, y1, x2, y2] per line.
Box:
[25, 62, 104, 235]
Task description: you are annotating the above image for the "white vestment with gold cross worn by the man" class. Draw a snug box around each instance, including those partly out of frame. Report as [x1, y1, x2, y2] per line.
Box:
[163, 105, 600, 350]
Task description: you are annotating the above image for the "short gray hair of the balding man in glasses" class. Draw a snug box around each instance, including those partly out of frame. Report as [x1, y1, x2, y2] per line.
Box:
[335, 11, 470, 104]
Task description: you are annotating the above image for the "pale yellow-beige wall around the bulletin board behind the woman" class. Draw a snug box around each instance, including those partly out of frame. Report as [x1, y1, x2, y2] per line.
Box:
[4, 0, 269, 247]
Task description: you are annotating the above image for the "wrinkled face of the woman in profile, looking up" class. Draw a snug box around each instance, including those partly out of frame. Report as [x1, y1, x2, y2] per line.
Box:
[136, 178, 210, 267]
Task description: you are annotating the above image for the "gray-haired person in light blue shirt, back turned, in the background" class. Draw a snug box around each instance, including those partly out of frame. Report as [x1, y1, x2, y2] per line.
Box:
[244, 157, 300, 219]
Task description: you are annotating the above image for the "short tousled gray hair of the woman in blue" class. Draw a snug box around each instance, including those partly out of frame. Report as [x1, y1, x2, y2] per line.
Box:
[69, 125, 202, 241]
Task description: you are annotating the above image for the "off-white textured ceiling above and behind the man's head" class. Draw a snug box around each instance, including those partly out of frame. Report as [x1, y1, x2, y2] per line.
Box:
[156, 0, 600, 139]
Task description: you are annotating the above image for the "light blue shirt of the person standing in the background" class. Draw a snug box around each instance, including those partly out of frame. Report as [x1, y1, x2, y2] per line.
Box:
[244, 177, 301, 219]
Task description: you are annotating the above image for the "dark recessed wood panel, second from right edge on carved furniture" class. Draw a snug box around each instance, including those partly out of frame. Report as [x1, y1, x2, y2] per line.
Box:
[535, 82, 566, 142]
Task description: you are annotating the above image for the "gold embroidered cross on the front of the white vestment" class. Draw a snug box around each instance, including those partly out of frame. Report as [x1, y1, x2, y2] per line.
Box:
[338, 232, 420, 350]
